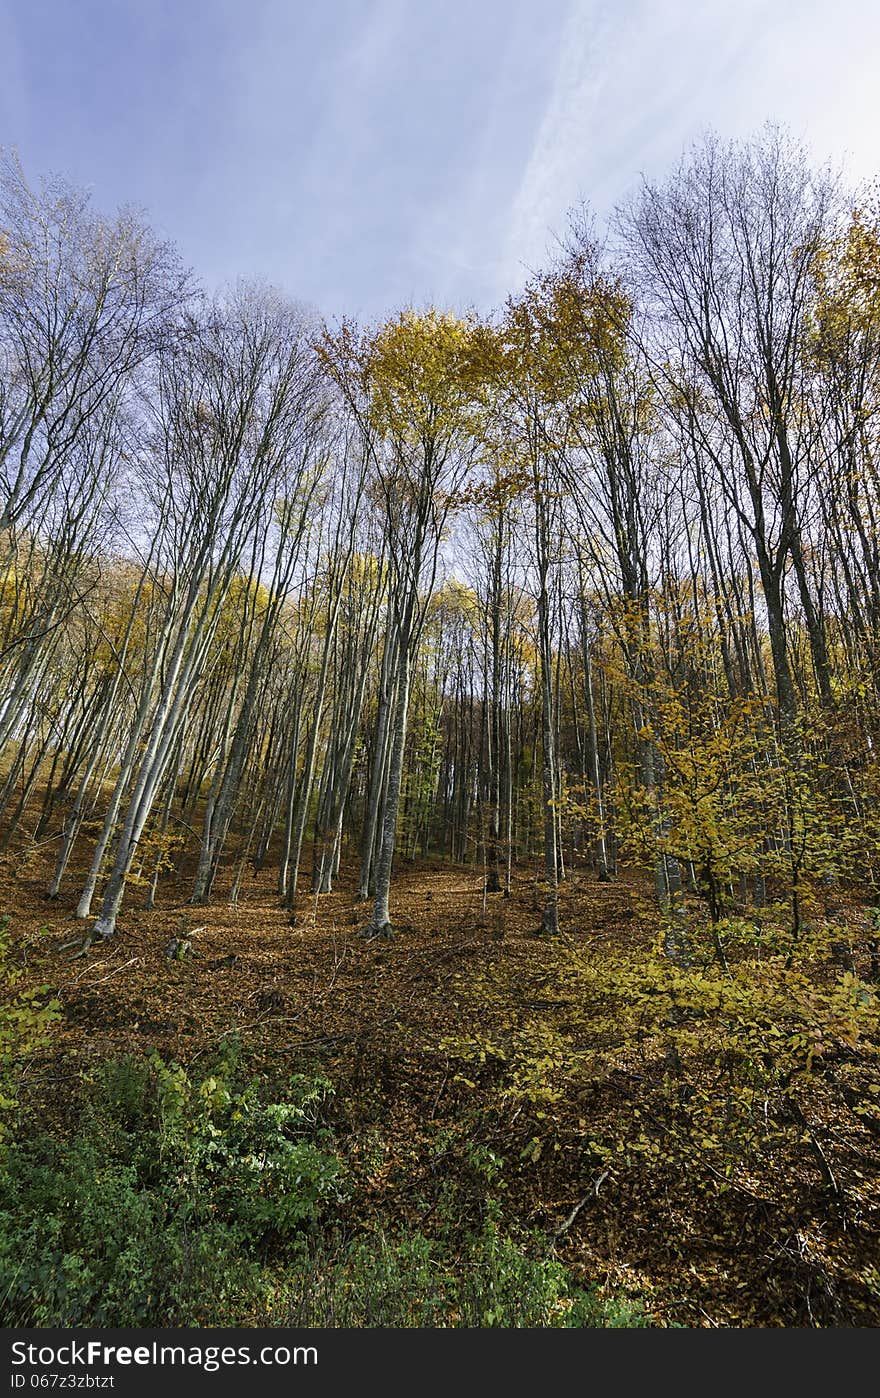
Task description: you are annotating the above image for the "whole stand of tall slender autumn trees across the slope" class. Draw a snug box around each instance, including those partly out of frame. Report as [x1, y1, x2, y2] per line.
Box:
[0, 130, 880, 958]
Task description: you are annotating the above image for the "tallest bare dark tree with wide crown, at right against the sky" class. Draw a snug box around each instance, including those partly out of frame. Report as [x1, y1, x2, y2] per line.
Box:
[621, 127, 835, 728]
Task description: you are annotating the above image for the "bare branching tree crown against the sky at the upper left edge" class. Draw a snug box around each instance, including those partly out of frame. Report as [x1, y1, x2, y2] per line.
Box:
[0, 155, 190, 534]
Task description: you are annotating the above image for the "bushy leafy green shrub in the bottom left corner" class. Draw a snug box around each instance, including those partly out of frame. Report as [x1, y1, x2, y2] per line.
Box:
[0, 1054, 339, 1325]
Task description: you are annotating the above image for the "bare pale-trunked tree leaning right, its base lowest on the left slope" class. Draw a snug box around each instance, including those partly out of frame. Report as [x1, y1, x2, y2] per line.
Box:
[78, 288, 323, 938]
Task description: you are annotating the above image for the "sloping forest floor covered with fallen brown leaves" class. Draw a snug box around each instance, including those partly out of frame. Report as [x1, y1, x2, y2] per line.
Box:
[0, 865, 880, 1327]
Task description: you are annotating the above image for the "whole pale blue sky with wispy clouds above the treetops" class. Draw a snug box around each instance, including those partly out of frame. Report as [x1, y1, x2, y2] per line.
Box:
[0, 0, 880, 319]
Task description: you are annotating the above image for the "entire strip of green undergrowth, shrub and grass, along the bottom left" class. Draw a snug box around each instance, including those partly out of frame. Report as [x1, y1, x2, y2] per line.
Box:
[0, 1044, 646, 1328]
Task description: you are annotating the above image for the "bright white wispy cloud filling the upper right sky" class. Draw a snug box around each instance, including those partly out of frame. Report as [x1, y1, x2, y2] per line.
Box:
[505, 0, 880, 285]
